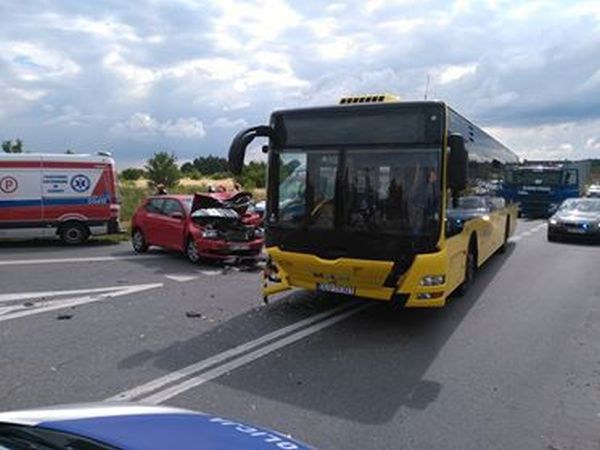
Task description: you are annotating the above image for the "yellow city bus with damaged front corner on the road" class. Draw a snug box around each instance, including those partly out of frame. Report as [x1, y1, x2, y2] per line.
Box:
[229, 95, 518, 307]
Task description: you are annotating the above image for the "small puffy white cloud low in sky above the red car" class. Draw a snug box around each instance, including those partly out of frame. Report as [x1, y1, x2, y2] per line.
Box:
[110, 113, 206, 139]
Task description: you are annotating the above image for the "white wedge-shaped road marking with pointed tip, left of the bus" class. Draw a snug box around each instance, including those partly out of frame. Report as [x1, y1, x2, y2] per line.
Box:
[0, 283, 163, 322]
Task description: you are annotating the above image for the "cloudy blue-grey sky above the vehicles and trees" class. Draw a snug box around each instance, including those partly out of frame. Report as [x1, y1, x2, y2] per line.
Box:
[0, 0, 600, 168]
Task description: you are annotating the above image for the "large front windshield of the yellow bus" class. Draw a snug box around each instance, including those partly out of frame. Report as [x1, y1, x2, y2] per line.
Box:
[271, 148, 441, 236]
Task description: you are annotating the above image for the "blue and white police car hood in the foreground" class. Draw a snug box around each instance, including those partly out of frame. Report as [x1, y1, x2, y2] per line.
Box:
[0, 403, 309, 450]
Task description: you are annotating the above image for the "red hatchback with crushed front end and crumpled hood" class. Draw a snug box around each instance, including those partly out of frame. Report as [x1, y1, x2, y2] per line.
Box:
[131, 192, 264, 263]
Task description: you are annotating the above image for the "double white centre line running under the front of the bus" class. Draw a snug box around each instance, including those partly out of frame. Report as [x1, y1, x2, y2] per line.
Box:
[106, 303, 373, 401]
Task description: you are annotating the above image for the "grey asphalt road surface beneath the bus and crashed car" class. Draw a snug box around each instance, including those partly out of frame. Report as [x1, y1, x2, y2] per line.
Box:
[0, 221, 600, 450]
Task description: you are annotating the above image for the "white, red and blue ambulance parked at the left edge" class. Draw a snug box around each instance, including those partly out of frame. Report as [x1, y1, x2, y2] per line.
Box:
[0, 153, 120, 245]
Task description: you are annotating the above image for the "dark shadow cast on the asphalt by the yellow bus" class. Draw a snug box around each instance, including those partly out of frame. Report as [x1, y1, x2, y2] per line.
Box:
[120, 244, 515, 424]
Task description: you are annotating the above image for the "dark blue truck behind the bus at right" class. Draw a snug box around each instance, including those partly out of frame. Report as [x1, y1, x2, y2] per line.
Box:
[502, 161, 590, 218]
